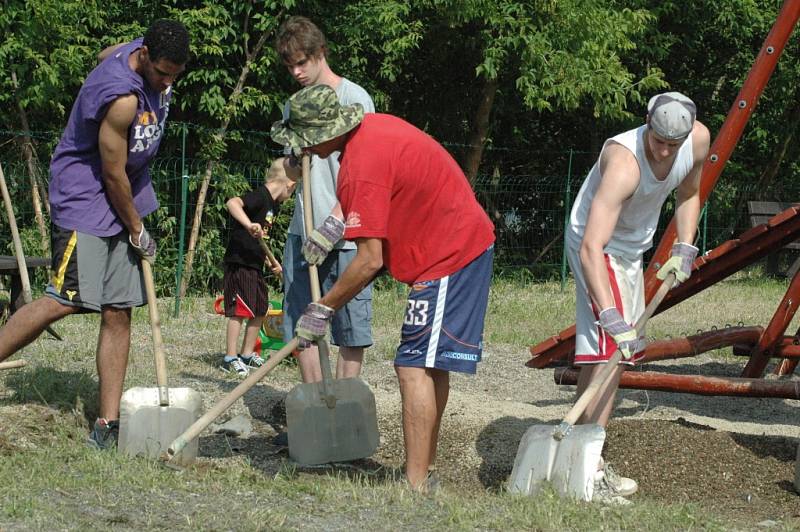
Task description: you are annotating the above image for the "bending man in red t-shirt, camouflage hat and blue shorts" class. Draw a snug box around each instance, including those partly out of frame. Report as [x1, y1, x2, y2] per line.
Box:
[271, 85, 495, 491]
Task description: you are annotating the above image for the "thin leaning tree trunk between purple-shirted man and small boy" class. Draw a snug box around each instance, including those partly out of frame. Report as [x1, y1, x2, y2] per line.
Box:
[179, 32, 272, 298]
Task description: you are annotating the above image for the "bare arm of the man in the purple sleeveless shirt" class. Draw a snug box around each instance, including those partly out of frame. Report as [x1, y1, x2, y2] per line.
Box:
[98, 94, 142, 238]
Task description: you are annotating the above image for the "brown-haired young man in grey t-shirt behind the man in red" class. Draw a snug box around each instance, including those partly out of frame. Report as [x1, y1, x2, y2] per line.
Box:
[275, 17, 375, 383]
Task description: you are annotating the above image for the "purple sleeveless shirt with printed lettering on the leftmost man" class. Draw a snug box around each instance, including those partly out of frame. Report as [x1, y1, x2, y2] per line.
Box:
[49, 39, 172, 236]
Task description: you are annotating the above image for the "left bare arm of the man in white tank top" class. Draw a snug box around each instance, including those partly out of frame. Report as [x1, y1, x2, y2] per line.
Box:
[580, 143, 639, 310]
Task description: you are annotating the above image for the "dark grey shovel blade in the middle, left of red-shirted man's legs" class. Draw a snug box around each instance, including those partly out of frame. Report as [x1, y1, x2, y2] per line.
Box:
[286, 378, 379, 465]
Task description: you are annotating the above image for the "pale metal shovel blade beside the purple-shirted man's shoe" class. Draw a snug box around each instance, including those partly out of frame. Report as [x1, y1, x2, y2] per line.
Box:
[118, 387, 202, 466]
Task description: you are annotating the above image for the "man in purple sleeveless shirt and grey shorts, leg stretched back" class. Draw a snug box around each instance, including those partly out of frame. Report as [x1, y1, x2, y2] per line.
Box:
[0, 20, 189, 449]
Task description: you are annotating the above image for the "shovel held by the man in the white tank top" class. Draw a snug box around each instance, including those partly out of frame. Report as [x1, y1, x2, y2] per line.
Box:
[508, 274, 675, 501]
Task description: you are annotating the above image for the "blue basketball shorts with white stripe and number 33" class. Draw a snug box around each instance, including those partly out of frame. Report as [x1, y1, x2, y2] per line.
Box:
[394, 245, 494, 374]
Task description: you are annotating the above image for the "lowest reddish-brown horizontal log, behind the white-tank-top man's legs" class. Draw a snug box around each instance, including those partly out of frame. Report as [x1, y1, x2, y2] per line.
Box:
[553, 368, 800, 399]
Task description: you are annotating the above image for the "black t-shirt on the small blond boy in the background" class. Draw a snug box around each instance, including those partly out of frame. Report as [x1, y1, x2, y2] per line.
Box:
[225, 185, 278, 271]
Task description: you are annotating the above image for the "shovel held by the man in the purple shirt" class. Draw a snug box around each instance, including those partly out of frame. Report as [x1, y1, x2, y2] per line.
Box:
[118, 259, 202, 465]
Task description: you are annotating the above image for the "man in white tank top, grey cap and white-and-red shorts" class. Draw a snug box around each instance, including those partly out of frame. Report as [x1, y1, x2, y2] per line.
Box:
[567, 92, 710, 503]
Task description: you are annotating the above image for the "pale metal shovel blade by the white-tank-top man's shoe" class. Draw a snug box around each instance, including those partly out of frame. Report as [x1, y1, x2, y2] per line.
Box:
[508, 425, 606, 501]
